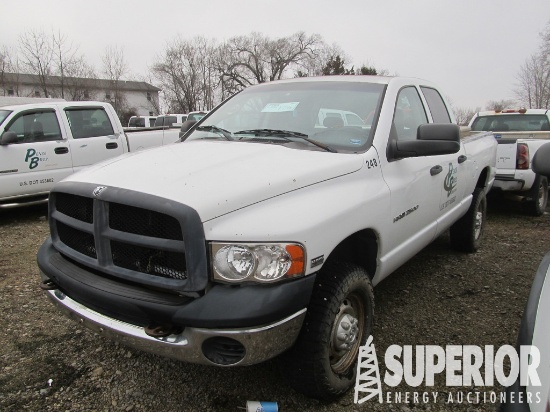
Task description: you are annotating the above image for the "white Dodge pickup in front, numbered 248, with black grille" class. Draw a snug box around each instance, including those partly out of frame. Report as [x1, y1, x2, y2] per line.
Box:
[37, 76, 496, 399]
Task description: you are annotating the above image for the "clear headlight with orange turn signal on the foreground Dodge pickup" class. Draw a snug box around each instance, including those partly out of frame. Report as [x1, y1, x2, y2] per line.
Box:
[211, 243, 305, 282]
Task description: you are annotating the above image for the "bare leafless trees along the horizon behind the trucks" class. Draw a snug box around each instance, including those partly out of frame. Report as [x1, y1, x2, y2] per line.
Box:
[0, 22, 550, 124]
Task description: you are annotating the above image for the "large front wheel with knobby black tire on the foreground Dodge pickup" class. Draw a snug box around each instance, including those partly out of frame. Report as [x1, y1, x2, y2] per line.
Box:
[279, 262, 374, 401]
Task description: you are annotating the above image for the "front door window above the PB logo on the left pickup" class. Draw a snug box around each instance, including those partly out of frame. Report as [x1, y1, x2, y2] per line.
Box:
[6, 111, 62, 143]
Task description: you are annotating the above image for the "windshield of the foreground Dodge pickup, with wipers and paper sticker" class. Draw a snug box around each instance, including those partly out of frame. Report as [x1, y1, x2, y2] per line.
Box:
[186, 81, 384, 153]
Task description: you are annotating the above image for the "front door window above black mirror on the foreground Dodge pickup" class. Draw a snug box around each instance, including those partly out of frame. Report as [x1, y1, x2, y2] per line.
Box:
[393, 86, 428, 140]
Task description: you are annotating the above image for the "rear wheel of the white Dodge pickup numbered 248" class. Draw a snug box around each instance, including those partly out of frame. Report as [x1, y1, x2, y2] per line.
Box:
[451, 187, 487, 253]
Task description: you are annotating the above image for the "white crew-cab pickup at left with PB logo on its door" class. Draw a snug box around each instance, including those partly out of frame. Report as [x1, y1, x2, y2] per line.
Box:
[0, 101, 179, 209]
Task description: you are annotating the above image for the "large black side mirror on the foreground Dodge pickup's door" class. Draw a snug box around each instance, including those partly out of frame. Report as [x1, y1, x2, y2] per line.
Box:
[391, 123, 460, 159]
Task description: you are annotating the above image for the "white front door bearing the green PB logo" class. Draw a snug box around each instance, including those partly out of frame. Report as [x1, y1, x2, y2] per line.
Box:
[0, 108, 73, 199]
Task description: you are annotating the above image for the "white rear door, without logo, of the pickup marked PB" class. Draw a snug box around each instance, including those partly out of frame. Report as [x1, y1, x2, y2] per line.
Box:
[64, 106, 124, 171]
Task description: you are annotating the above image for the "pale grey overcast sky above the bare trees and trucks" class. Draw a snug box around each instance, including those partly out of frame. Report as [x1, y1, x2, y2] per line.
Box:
[0, 0, 550, 109]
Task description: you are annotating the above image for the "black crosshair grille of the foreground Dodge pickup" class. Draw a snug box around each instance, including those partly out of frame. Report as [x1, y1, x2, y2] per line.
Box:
[50, 192, 192, 286]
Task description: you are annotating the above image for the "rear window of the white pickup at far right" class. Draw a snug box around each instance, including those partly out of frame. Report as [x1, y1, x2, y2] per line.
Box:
[472, 114, 550, 132]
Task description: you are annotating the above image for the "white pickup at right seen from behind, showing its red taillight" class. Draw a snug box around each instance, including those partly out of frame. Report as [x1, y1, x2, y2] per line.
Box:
[470, 109, 550, 216]
